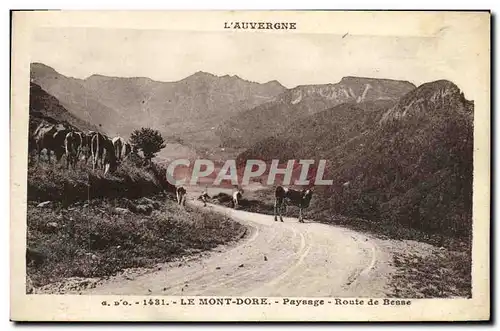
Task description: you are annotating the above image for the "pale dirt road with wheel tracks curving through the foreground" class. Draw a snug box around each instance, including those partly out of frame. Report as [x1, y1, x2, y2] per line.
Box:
[82, 201, 392, 297]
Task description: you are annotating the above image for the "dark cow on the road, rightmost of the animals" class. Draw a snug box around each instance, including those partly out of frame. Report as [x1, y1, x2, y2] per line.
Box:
[274, 186, 313, 223]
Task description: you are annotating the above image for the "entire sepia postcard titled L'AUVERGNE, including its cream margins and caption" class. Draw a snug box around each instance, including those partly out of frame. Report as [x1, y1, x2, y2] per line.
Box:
[11, 11, 490, 321]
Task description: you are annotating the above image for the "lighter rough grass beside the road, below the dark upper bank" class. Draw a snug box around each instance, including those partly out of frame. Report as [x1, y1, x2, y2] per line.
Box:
[27, 198, 243, 287]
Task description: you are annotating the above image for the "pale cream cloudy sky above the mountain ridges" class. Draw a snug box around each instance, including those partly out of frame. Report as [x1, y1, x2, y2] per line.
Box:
[31, 24, 484, 99]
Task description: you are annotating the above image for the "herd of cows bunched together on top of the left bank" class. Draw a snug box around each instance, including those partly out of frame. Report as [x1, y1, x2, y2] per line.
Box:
[31, 122, 132, 174]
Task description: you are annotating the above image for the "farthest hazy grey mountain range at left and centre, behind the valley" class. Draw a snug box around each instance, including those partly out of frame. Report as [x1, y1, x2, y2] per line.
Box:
[31, 63, 285, 152]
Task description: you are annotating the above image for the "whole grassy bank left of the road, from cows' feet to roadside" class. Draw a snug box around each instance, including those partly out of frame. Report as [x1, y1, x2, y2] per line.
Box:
[27, 152, 244, 288]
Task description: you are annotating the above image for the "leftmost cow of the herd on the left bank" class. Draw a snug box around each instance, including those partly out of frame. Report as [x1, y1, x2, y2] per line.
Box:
[34, 123, 69, 163]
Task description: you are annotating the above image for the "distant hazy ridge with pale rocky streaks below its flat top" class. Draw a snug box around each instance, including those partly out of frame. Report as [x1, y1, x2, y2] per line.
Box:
[217, 77, 415, 147]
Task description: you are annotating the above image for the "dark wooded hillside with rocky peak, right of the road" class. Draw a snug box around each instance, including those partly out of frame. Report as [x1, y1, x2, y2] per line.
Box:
[240, 81, 473, 241]
